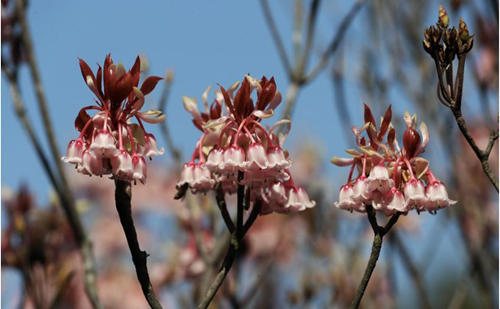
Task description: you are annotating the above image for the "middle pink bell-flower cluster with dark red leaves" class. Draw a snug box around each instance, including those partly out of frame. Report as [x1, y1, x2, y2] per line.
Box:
[177, 75, 315, 213]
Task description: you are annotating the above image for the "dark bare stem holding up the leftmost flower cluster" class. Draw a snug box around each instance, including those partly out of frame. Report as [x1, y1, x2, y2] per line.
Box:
[115, 180, 162, 309]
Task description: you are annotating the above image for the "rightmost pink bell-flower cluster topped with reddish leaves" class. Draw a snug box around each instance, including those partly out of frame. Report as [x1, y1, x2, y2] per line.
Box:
[332, 105, 456, 215]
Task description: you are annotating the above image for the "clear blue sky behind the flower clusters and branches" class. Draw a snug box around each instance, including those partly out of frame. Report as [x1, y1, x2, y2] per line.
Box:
[2, 1, 361, 199]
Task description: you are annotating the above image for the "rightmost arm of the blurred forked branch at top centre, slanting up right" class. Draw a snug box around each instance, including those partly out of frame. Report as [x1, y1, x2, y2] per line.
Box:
[304, 0, 364, 83]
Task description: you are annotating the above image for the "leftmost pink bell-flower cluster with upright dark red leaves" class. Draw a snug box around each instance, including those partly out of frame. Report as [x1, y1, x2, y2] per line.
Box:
[62, 55, 165, 183]
